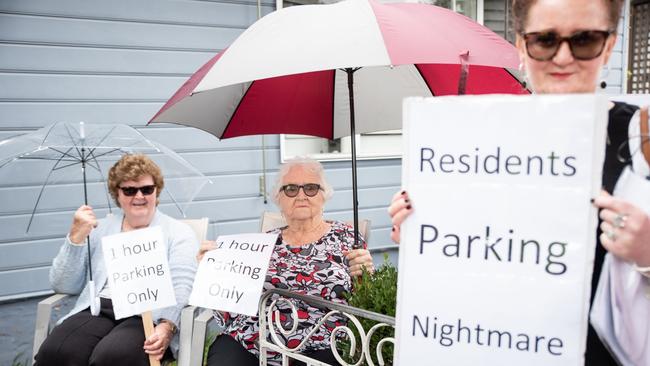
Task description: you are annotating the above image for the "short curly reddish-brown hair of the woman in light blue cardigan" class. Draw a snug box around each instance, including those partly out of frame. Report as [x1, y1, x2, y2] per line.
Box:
[108, 154, 165, 207]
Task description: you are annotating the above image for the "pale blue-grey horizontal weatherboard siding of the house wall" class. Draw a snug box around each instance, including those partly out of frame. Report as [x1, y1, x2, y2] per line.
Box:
[0, 0, 400, 301]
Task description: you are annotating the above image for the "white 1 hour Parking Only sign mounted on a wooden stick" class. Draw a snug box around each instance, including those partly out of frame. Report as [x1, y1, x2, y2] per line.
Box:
[102, 226, 176, 319]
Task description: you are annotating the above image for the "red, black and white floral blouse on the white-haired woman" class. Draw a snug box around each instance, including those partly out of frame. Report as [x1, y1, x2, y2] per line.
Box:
[215, 221, 366, 365]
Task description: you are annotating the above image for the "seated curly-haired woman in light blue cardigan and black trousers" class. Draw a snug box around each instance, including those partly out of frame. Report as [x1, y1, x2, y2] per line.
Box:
[35, 155, 198, 366]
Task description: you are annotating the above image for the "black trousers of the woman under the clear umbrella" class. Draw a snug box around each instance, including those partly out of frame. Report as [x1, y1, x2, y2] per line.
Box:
[34, 298, 171, 366]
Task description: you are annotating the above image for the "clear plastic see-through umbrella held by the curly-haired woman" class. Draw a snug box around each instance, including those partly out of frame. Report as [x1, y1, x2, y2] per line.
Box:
[0, 122, 210, 314]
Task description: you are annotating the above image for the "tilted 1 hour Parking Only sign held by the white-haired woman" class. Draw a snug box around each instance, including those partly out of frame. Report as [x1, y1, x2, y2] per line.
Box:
[190, 233, 278, 315]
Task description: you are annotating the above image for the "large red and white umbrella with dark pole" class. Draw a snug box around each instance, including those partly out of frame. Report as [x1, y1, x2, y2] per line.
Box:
[150, 0, 527, 246]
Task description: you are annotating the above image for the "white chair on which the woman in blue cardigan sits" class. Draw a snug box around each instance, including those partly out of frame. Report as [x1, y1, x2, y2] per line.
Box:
[31, 217, 209, 366]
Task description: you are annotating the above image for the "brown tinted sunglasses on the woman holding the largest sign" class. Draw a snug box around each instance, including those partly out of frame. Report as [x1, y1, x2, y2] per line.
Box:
[522, 30, 613, 61]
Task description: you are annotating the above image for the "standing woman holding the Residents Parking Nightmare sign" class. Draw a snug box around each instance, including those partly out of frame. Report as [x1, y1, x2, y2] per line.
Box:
[388, 0, 650, 366]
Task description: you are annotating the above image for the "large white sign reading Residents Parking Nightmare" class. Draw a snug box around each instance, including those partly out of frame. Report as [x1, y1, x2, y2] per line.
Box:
[395, 95, 608, 366]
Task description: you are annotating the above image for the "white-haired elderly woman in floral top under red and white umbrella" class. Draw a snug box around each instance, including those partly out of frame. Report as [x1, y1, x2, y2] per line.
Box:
[199, 159, 373, 366]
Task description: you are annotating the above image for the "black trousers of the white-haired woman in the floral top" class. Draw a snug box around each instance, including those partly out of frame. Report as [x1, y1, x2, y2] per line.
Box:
[208, 334, 338, 366]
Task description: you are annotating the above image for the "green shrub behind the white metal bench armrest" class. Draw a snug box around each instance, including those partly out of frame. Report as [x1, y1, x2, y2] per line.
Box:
[339, 254, 397, 365]
